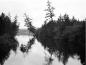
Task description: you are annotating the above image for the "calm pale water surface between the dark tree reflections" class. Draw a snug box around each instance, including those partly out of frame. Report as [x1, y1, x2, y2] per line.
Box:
[4, 35, 81, 65]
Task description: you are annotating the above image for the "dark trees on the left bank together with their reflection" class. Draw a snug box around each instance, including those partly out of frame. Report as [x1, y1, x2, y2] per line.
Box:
[0, 13, 18, 65]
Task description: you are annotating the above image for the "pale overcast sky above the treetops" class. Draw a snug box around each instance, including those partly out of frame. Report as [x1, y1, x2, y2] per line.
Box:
[0, 0, 86, 28]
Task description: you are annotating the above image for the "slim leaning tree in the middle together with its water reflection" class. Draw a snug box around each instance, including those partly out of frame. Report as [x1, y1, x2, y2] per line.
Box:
[20, 13, 36, 53]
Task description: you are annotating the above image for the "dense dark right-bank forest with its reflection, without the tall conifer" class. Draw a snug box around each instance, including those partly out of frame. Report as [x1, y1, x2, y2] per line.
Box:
[25, 14, 86, 65]
